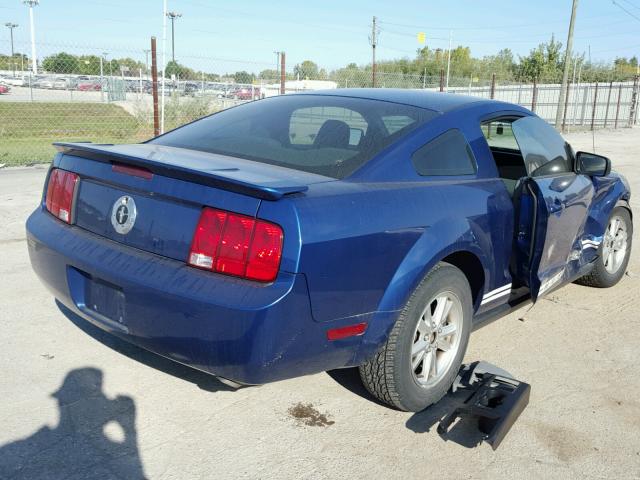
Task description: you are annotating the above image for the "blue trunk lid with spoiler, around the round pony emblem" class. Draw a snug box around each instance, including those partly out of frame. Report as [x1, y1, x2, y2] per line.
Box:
[56, 144, 332, 261]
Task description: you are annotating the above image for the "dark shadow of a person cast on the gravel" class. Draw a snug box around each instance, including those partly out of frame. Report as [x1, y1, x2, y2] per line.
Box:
[0, 368, 145, 480]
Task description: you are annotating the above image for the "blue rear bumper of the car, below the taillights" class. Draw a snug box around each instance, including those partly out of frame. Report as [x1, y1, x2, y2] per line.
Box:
[27, 208, 361, 384]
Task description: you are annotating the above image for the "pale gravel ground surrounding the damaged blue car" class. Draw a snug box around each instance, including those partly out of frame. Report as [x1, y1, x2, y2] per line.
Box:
[0, 129, 640, 479]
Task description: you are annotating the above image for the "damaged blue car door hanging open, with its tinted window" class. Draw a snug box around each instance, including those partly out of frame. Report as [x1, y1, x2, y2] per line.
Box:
[512, 117, 595, 302]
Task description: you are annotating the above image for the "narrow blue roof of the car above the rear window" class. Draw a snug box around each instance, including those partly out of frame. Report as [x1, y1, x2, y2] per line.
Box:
[300, 88, 521, 113]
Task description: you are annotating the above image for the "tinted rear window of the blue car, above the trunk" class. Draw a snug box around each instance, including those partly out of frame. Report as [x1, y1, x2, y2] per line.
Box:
[149, 94, 438, 178]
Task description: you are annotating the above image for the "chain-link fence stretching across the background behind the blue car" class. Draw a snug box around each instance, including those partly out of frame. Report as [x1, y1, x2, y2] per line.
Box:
[0, 42, 639, 165]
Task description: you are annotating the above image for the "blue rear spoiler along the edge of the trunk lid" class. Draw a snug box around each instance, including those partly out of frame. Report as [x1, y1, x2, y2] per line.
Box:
[53, 142, 309, 200]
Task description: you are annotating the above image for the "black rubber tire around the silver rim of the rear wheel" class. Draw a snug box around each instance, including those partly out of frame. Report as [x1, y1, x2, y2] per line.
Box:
[359, 262, 473, 412]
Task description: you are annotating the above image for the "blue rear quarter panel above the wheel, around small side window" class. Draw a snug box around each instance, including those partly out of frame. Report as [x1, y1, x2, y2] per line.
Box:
[284, 103, 513, 363]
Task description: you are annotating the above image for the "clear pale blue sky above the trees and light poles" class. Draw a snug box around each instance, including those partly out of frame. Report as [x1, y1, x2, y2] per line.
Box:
[0, 0, 640, 73]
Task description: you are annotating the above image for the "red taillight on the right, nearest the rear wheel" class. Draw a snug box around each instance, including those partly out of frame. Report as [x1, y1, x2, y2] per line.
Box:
[187, 208, 283, 282]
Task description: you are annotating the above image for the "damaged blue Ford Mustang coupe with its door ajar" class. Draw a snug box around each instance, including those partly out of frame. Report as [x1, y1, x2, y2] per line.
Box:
[27, 89, 632, 411]
